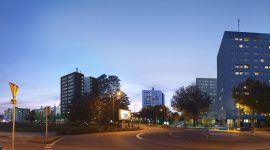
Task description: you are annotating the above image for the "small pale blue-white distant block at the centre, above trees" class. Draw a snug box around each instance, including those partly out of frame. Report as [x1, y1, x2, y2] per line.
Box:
[142, 88, 165, 107]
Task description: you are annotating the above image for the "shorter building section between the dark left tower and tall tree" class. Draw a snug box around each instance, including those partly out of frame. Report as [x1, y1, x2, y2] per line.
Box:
[84, 76, 98, 96]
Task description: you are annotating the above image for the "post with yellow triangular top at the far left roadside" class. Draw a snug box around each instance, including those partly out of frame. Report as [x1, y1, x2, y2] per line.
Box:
[9, 82, 19, 150]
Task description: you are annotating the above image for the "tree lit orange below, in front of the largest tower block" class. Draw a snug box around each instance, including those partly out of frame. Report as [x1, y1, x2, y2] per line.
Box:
[232, 78, 270, 127]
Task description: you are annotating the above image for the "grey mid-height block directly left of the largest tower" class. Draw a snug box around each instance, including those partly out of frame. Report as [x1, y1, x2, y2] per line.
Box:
[196, 78, 218, 118]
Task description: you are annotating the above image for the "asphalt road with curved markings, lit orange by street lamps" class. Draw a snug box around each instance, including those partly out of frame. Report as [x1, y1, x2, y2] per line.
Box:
[0, 127, 270, 150]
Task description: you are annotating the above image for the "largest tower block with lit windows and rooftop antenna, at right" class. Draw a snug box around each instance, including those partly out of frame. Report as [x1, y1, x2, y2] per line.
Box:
[217, 31, 270, 119]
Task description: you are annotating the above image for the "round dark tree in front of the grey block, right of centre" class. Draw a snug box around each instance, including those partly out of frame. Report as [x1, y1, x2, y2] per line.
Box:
[171, 85, 211, 126]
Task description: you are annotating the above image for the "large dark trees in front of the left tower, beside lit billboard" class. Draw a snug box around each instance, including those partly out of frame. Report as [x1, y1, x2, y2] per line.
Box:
[68, 74, 130, 124]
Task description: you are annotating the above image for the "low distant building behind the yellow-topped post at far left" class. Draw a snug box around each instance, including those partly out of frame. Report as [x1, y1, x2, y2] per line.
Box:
[4, 107, 30, 122]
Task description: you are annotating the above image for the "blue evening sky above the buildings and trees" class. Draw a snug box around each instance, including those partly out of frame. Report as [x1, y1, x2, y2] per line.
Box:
[0, 0, 270, 111]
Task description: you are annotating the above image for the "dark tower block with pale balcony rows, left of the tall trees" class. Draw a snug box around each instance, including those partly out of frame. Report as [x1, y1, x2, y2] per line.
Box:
[60, 70, 84, 115]
